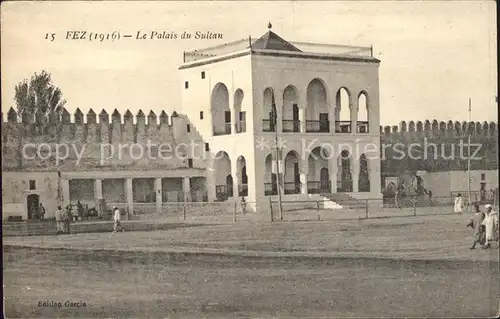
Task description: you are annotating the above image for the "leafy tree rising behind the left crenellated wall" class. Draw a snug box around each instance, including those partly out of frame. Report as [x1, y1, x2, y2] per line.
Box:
[14, 70, 66, 115]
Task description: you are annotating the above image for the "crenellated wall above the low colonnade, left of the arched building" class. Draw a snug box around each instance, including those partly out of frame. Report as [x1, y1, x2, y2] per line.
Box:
[2, 108, 205, 171]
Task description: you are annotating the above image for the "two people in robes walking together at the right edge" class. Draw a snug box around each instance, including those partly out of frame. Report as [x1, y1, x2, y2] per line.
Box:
[467, 204, 499, 249]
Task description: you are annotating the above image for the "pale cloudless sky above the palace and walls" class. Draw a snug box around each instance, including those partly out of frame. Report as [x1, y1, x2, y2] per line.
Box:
[1, 1, 498, 125]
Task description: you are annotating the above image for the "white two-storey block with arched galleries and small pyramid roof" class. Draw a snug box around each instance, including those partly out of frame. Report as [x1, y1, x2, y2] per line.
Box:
[179, 23, 381, 215]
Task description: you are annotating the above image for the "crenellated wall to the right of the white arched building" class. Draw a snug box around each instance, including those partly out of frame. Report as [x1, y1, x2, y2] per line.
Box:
[380, 120, 498, 175]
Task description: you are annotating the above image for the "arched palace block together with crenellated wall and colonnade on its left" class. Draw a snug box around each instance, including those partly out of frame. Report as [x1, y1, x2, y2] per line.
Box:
[2, 28, 382, 219]
